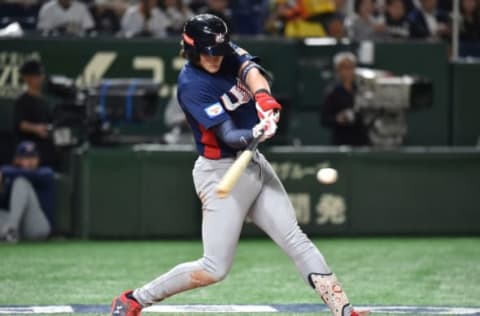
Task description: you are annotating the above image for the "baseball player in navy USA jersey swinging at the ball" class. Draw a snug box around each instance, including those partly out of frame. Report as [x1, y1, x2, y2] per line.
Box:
[111, 14, 368, 316]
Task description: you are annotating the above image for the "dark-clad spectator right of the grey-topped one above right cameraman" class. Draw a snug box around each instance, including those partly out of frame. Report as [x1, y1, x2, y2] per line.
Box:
[383, 0, 410, 38]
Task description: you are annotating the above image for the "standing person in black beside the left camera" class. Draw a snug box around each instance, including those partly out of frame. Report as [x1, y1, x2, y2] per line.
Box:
[14, 59, 57, 166]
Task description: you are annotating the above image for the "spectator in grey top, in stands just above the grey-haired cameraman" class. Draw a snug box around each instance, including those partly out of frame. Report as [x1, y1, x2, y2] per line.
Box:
[346, 0, 385, 41]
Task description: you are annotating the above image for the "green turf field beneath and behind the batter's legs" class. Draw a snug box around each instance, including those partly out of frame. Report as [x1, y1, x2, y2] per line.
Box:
[0, 238, 480, 316]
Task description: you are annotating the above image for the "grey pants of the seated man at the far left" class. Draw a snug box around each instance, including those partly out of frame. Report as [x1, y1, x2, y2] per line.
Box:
[0, 177, 51, 240]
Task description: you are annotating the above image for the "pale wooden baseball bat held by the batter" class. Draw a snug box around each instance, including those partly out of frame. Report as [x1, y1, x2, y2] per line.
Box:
[216, 133, 263, 199]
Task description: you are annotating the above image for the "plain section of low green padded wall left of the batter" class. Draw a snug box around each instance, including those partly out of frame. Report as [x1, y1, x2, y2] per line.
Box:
[74, 148, 201, 238]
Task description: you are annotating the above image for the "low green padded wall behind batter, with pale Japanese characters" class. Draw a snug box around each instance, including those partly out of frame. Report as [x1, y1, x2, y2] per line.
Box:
[71, 147, 480, 238]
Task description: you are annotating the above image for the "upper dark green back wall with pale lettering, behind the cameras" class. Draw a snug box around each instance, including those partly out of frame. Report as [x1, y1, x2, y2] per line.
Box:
[0, 37, 462, 146]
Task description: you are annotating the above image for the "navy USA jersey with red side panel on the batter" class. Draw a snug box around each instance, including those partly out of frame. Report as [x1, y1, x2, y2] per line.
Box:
[177, 44, 258, 159]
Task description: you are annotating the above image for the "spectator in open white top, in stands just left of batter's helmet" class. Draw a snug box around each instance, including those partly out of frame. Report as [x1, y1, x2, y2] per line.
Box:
[121, 0, 170, 37]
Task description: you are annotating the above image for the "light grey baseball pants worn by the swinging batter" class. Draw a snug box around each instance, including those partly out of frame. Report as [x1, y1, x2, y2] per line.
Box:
[133, 152, 330, 306]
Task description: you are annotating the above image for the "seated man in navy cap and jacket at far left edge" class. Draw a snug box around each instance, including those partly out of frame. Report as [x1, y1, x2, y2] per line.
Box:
[0, 141, 53, 242]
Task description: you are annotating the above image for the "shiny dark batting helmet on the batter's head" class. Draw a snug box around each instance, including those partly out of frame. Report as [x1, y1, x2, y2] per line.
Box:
[182, 14, 233, 60]
